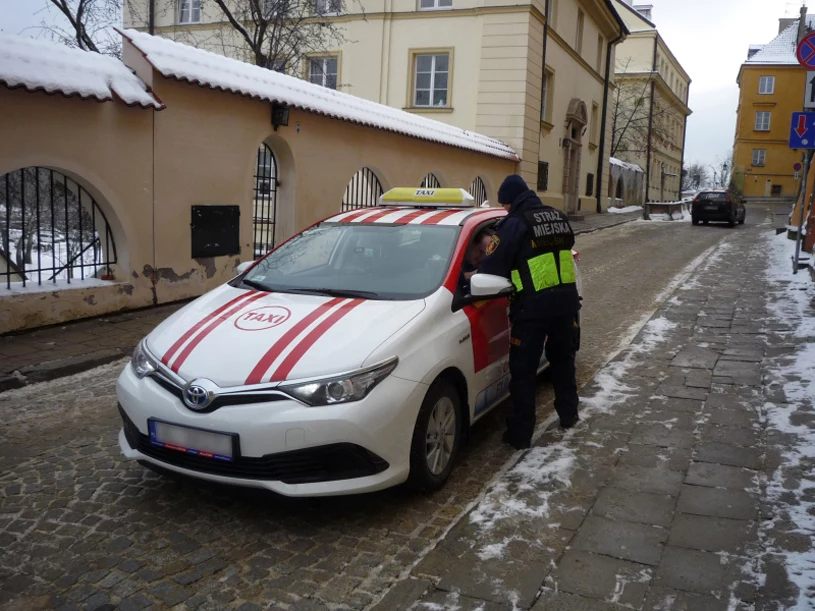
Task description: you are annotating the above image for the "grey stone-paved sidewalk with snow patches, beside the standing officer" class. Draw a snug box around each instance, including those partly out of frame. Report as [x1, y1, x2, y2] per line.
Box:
[375, 214, 815, 611]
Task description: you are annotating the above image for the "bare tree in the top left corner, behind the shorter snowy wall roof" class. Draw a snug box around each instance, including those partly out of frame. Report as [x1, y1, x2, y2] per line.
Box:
[39, 0, 122, 57]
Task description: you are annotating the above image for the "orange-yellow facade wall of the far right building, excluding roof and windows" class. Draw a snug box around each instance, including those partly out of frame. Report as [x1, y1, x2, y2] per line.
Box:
[733, 66, 806, 197]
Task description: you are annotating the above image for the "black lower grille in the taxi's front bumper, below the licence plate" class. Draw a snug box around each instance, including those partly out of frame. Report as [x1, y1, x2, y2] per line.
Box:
[119, 405, 389, 484]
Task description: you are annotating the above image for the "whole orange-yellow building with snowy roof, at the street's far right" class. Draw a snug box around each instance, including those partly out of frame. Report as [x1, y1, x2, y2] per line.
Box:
[733, 15, 815, 198]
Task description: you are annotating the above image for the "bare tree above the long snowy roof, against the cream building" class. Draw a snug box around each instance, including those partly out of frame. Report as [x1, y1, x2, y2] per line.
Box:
[204, 0, 362, 77]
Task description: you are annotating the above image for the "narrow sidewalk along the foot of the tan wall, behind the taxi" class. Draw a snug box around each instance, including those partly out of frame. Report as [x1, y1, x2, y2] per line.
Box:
[0, 213, 640, 392]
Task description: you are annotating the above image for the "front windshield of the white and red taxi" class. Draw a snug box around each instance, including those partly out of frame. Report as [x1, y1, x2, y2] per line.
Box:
[242, 223, 459, 299]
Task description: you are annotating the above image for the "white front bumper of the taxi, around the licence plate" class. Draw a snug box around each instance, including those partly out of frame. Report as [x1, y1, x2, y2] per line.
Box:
[116, 365, 434, 496]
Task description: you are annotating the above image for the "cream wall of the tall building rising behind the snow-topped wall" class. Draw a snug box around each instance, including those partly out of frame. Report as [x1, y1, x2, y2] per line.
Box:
[125, 0, 619, 212]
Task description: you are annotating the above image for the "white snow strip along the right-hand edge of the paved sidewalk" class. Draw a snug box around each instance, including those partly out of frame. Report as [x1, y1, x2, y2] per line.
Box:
[764, 234, 815, 611]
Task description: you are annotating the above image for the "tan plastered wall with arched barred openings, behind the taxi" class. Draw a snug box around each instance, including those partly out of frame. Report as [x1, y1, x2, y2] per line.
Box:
[0, 45, 516, 333]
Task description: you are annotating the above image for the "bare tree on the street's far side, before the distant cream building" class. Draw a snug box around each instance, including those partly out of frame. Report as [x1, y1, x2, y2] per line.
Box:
[611, 58, 670, 157]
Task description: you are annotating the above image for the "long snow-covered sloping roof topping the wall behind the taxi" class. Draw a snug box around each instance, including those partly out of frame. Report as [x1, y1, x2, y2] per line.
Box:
[119, 30, 519, 161]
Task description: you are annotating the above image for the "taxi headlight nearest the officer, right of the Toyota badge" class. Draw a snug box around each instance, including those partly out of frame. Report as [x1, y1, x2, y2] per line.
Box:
[279, 357, 399, 407]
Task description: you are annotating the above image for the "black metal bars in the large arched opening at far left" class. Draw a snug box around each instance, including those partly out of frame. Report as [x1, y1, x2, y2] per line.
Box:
[0, 167, 116, 289]
